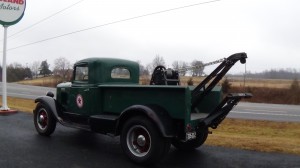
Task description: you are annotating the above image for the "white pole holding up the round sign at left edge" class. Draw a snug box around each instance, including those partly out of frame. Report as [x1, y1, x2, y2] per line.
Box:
[1, 26, 9, 111]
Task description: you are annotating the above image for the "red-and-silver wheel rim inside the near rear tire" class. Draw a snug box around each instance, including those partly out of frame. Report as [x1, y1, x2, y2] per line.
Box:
[126, 125, 151, 157]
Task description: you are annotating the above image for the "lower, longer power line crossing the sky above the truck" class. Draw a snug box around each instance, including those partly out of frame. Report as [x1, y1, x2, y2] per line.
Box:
[7, 0, 221, 51]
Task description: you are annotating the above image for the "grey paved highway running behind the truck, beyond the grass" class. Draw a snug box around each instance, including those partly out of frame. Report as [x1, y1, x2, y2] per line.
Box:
[0, 83, 300, 122]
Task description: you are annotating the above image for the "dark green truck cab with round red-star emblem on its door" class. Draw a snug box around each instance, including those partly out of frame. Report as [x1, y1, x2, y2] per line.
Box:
[57, 58, 139, 116]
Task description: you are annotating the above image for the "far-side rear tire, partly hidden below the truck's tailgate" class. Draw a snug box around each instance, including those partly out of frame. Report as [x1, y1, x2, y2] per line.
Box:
[172, 128, 208, 151]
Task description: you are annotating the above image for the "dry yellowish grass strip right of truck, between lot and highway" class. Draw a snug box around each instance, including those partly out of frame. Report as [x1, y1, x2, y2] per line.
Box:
[206, 119, 300, 155]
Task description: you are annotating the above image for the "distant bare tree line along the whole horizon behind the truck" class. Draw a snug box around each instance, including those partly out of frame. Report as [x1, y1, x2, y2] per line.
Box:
[0, 55, 300, 82]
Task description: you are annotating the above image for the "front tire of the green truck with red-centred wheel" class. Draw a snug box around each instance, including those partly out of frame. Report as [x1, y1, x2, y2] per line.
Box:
[33, 103, 56, 136]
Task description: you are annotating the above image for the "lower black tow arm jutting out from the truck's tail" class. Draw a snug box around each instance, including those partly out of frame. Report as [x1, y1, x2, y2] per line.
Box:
[199, 93, 252, 129]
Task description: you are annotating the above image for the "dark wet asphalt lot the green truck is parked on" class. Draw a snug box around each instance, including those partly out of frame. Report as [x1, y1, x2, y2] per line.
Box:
[0, 112, 300, 168]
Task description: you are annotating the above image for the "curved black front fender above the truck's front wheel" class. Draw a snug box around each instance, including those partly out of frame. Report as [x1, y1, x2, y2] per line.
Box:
[34, 96, 63, 122]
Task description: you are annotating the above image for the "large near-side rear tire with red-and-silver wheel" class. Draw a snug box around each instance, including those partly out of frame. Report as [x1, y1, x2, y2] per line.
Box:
[120, 116, 171, 165]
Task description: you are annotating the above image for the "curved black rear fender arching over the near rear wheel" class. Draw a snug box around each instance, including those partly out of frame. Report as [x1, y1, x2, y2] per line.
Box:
[117, 105, 175, 138]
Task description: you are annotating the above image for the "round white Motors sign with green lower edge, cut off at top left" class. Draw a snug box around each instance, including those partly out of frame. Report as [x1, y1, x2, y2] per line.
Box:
[0, 0, 26, 26]
